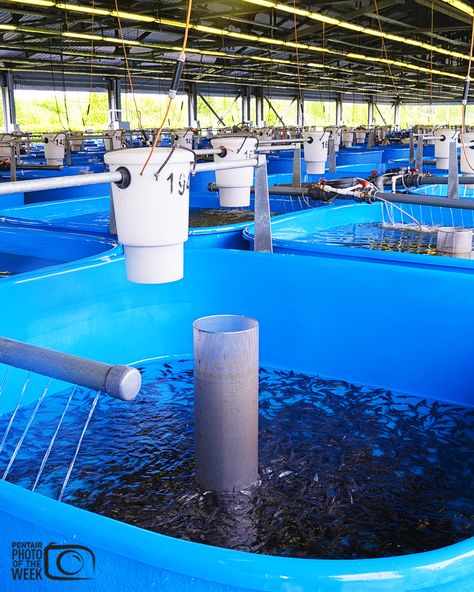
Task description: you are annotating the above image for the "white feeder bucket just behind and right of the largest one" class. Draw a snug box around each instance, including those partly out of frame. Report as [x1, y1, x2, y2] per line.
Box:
[211, 134, 257, 208]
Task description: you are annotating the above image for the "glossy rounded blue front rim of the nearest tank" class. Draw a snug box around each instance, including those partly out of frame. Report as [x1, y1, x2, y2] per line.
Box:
[0, 464, 474, 592]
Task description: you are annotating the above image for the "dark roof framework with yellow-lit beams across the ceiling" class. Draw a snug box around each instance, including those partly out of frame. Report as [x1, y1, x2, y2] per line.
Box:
[0, 0, 473, 103]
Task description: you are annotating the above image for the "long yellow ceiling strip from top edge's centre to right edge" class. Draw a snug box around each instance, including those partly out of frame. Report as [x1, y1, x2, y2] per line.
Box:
[241, 0, 472, 60]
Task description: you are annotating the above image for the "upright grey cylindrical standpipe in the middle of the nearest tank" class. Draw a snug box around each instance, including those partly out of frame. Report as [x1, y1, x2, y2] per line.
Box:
[193, 315, 258, 492]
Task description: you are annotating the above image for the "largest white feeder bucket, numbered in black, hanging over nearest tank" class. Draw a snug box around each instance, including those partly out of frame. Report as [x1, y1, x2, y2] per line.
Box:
[104, 148, 194, 284]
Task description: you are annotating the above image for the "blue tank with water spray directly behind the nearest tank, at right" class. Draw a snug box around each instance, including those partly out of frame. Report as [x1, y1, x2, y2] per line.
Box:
[244, 202, 474, 269]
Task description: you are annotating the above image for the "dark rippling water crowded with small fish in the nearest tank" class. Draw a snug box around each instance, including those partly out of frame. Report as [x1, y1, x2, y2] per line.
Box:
[0, 356, 474, 559]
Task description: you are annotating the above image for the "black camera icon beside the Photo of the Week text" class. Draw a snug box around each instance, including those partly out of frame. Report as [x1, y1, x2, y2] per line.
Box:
[44, 543, 95, 580]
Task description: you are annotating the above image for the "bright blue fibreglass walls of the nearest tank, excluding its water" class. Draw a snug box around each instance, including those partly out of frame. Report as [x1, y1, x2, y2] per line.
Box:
[0, 249, 474, 592]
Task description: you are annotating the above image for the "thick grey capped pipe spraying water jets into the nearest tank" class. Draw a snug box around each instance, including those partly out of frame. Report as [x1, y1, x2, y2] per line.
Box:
[0, 337, 142, 401]
